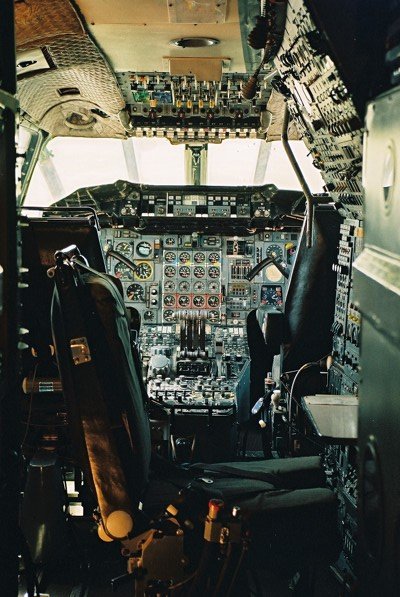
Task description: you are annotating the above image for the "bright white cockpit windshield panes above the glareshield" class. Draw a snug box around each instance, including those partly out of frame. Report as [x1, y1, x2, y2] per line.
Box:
[25, 137, 324, 206]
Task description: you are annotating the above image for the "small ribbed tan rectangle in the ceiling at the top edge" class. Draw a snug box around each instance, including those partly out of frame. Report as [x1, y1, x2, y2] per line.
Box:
[167, 0, 227, 23]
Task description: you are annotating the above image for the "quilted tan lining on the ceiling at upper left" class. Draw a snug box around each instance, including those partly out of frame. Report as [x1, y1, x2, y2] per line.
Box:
[17, 0, 126, 137]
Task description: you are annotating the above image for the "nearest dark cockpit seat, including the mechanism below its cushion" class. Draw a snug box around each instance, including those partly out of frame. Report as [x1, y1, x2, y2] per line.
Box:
[36, 236, 339, 596]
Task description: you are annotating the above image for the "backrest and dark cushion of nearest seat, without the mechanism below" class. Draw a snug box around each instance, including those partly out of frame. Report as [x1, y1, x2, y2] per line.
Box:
[51, 244, 338, 588]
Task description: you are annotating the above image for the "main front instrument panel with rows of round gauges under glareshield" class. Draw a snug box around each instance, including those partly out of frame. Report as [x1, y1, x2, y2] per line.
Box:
[101, 228, 298, 325]
